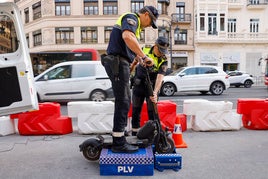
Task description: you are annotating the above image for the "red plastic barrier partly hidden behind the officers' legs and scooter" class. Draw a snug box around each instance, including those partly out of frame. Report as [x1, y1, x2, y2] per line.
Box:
[128, 100, 177, 131]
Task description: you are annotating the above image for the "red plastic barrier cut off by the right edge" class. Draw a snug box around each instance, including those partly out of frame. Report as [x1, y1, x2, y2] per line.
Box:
[237, 98, 268, 129]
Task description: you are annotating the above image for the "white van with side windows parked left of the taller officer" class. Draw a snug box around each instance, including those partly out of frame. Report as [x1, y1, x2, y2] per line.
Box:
[35, 61, 113, 101]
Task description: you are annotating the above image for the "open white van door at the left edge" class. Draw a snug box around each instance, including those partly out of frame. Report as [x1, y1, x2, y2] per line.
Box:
[0, 2, 38, 116]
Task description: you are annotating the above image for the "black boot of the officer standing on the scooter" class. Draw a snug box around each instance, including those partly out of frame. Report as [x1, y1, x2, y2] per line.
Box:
[111, 136, 139, 153]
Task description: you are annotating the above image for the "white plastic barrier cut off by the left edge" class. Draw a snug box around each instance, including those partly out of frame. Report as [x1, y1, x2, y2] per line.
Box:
[0, 116, 16, 136]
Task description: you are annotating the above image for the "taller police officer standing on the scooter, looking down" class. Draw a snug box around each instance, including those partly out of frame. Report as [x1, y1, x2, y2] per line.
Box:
[102, 6, 159, 153]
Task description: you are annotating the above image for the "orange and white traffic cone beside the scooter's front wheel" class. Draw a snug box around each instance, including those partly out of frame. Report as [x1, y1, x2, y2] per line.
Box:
[172, 115, 187, 148]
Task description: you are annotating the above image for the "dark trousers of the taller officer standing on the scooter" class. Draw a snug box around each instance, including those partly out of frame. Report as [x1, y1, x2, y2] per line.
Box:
[103, 57, 131, 132]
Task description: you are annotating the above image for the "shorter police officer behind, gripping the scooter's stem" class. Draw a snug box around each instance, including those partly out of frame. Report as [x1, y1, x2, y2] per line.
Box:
[131, 37, 169, 135]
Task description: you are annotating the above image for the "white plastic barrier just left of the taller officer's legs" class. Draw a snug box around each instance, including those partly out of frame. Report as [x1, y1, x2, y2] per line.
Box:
[67, 101, 114, 134]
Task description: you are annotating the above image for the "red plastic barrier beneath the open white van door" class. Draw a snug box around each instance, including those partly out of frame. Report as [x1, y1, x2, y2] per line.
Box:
[18, 103, 73, 135]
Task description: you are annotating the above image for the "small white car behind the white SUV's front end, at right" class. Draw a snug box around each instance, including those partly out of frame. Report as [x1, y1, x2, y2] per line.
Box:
[228, 71, 254, 88]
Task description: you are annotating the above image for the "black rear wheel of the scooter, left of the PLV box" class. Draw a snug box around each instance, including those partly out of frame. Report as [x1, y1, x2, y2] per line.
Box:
[83, 143, 102, 161]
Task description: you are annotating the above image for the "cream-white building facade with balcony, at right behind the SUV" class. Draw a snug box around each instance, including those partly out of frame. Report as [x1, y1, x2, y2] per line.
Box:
[194, 0, 268, 77]
